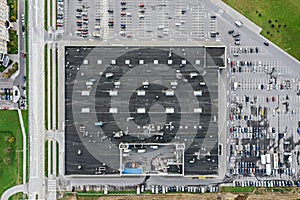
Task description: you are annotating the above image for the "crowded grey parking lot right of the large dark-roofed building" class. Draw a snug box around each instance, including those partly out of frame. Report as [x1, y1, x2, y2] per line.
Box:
[227, 46, 300, 179]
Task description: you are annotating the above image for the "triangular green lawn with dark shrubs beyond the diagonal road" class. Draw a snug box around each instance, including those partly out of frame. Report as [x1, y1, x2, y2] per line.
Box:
[223, 0, 300, 60]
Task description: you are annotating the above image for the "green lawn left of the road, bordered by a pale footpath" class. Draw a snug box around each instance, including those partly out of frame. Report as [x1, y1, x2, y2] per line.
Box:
[0, 110, 23, 196]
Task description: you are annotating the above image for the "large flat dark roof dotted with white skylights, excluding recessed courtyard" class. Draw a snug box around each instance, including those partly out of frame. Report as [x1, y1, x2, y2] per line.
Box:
[65, 47, 224, 175]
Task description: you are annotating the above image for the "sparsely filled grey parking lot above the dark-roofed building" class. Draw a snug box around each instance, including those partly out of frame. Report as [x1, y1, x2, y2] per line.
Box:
[58, 0, 218, 41]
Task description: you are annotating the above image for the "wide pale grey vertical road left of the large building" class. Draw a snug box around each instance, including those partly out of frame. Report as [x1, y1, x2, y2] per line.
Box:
[28, 0, 46, 199]
